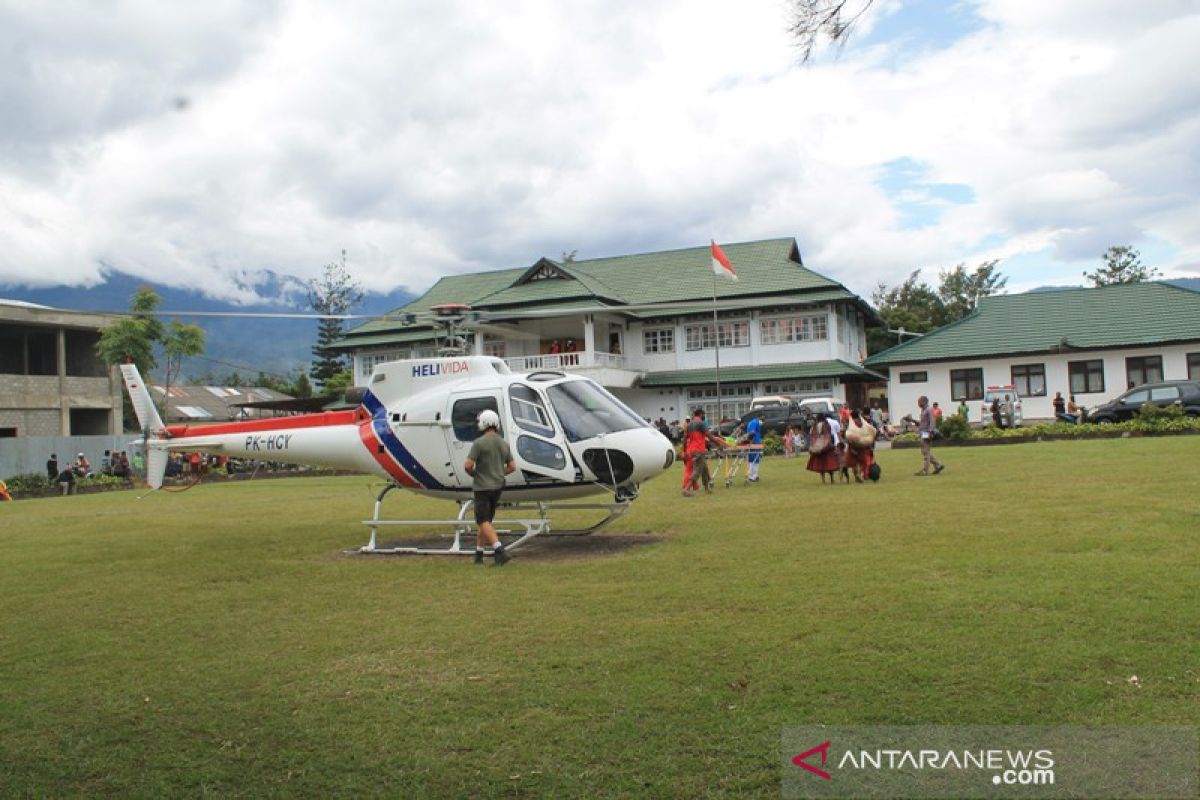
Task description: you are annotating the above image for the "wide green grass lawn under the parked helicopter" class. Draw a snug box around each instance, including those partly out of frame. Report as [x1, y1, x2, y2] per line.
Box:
[0, 437, 1200, 798]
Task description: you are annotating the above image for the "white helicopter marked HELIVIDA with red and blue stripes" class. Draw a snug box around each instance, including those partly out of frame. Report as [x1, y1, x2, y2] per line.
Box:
[120, 305, 676, 554]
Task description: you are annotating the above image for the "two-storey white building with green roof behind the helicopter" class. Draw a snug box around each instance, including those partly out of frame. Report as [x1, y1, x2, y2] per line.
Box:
[340, 239, 882, 420]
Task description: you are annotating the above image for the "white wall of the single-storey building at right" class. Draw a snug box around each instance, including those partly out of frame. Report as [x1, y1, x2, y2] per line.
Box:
[888, 342, 1200, 421]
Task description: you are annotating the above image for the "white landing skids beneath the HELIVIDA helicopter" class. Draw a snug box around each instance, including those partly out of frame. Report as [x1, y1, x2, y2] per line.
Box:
[359, 483, 632, 555]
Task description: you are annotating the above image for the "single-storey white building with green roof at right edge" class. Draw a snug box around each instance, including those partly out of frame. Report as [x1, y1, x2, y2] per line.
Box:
[865, 282, 1200, 421]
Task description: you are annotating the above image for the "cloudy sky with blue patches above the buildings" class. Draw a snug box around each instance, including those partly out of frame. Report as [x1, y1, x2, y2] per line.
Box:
[0, 0, 1200, 304]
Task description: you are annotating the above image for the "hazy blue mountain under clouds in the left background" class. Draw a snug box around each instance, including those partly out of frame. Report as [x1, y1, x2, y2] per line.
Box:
[0, 272, 412, 377]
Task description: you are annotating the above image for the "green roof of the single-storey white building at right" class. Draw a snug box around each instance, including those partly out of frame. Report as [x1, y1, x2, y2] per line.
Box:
[866, 281, 1200, 367]
